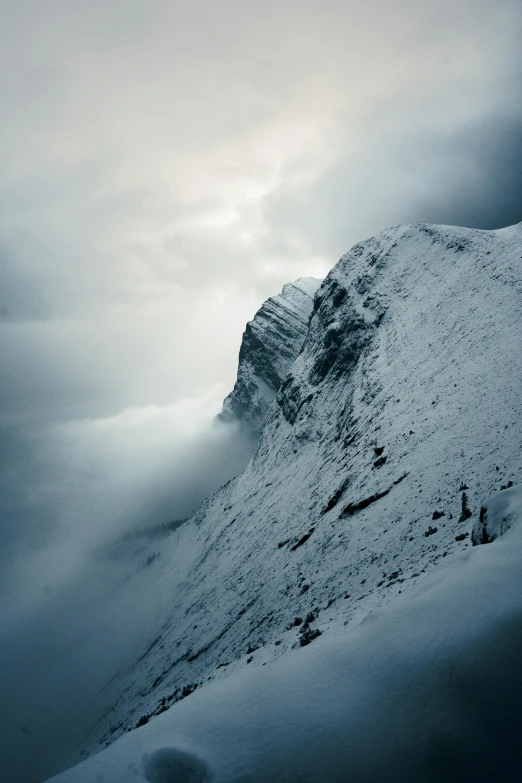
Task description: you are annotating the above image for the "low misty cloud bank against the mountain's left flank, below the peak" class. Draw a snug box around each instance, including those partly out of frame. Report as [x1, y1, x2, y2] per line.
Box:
[0, 387, 253, 783]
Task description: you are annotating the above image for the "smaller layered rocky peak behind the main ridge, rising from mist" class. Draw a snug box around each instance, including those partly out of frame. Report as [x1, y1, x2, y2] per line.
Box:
[218, 277, 321, 433]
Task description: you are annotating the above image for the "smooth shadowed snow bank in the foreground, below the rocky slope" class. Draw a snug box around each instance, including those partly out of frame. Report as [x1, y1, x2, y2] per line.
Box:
[46, 486, 522, 783]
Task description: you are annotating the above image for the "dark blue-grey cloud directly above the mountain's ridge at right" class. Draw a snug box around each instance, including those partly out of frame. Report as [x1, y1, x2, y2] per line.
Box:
[267, 102, 522, 257]
